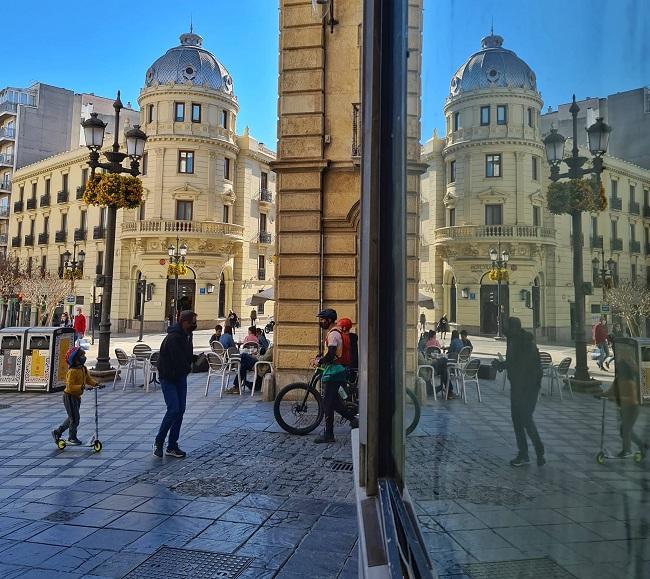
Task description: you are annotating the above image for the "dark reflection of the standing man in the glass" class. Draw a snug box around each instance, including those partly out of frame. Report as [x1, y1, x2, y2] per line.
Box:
[504, 318, 546, 467]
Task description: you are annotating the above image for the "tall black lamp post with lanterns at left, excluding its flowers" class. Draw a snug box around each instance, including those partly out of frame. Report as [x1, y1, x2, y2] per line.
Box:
[81, 91, 147, 372]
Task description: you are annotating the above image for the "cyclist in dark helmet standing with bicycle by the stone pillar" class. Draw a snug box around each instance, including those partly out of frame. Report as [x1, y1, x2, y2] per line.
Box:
[314, 308, 359, 444]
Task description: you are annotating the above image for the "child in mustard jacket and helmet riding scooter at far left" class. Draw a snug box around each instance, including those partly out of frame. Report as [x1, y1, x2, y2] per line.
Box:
[52, 347, 97, 446]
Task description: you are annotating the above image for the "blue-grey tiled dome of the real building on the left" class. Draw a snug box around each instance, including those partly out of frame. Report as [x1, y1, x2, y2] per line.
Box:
[145, 32, 233, 95]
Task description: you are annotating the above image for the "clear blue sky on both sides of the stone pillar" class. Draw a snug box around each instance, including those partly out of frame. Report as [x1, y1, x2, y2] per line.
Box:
[0, 0, 650, 148]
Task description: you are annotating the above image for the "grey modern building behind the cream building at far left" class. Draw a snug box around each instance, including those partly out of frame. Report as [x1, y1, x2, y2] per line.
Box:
[0, 83, 138, 252]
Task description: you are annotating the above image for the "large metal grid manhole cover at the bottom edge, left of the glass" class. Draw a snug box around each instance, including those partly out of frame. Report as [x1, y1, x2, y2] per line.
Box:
[124, 547, 253, 579]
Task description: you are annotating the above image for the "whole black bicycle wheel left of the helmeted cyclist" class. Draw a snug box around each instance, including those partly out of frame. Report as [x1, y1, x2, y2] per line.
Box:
[273, 382, 323, 434]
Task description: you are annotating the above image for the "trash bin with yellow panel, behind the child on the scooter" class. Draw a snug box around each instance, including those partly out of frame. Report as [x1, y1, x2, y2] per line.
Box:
[22, 328, 74, 392]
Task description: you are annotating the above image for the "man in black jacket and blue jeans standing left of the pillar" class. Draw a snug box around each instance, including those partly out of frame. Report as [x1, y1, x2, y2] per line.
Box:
[153, 310, 196, 458]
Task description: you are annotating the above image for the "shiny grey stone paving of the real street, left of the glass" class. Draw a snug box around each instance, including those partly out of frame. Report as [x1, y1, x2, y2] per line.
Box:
[0, 374, 358, 579]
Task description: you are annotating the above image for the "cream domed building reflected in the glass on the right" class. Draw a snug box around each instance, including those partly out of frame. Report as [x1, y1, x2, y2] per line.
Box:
[420, 35, 650, 339]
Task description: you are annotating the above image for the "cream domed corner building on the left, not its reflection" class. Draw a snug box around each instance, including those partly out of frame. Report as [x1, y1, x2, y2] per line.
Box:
[11, 33, 275, 330]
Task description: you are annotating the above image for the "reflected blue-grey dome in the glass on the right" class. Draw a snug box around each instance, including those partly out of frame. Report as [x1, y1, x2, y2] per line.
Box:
[449, 34, 537, 97]
